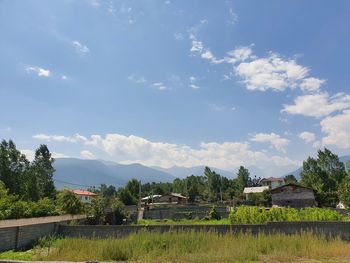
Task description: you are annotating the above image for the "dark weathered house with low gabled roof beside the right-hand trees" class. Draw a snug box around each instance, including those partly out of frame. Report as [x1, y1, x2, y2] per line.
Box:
[270, 184, 315, 208]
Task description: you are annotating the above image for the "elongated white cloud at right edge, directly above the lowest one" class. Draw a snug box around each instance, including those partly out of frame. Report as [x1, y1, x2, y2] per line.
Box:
[282, 92, 350, 118]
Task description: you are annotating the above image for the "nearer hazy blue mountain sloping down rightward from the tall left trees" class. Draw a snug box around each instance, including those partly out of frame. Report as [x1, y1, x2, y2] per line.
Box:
[54, 158, 175, 189]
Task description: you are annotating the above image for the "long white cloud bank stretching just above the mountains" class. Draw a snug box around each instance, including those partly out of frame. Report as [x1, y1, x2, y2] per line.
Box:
[37, 134, 301, 175]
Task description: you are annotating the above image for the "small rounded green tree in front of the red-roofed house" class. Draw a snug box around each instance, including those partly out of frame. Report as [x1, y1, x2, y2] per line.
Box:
[57, 190, 83, 215]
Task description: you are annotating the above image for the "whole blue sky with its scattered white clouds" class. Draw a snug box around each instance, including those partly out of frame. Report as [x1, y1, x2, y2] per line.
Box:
[0, 0, 350, 176]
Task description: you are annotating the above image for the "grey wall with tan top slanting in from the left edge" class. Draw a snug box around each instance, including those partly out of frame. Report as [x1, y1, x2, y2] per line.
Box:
[0, 215, 86, 254]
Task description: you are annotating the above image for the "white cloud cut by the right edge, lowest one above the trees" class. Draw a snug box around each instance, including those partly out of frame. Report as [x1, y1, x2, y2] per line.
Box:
[321, 110, 350, 149]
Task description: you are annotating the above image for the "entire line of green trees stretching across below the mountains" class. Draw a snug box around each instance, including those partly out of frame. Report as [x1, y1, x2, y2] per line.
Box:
[0, 140, 350, 222]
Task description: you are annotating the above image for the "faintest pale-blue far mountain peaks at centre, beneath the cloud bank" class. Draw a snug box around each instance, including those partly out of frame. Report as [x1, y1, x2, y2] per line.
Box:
[152, 165, 236, 178]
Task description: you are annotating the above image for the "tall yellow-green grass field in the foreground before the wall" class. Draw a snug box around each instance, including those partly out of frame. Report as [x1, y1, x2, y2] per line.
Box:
[0, 232, 350, 263]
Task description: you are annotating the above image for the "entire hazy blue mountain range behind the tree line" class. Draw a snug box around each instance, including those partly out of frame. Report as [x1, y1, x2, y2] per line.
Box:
[54, 155, 350, 189]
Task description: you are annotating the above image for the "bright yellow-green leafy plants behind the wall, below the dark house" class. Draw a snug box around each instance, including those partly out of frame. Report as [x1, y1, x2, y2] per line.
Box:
[229, 206, 344, 224]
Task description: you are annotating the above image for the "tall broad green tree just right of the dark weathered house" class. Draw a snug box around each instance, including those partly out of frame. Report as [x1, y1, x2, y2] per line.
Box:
[300, 148, 346, 206]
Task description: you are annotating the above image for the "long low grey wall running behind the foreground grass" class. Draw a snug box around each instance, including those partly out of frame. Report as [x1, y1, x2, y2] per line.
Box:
[58, 222, 350, 241]
